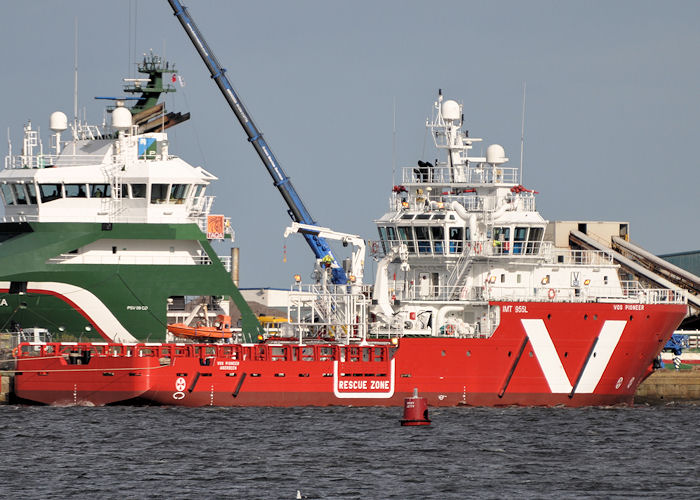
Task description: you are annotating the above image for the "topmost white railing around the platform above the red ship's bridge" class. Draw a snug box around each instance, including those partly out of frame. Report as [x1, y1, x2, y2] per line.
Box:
[401, 165, 520, 185]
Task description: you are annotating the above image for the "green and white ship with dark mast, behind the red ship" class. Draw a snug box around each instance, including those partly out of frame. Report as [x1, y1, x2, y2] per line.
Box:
[0, 56, 259, 342]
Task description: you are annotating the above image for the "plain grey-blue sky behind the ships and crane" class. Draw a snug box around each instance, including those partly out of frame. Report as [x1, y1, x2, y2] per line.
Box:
[0, 0, 700, 287]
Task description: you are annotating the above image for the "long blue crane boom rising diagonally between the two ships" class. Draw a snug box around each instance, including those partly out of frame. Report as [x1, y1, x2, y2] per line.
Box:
[168, 0, 347, 284]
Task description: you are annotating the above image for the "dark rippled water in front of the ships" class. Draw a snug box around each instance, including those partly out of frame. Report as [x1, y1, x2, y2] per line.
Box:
[0, 405, 700, 499]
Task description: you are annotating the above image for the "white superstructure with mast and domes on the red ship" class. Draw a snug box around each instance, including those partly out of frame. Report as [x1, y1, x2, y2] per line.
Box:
[290, 94, 685, 337]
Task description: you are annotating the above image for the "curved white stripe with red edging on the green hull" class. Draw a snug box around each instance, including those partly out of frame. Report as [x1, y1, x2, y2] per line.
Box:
[0, 281, 138, 342]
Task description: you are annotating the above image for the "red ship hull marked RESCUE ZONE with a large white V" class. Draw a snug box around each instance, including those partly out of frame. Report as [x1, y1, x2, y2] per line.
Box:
[17, 302, 686, 406]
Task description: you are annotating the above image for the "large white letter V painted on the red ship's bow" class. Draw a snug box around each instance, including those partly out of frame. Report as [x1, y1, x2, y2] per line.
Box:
[520, 319, 627, 394]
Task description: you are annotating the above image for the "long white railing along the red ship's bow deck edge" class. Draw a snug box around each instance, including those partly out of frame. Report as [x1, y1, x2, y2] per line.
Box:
[395, 282, 687, 304]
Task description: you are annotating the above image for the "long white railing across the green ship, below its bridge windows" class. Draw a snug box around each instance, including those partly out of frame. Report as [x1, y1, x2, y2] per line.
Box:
[47, 253, 231, 272]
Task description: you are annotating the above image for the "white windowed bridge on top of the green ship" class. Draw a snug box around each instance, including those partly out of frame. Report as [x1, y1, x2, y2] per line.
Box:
[0, 124, 232, 235]
